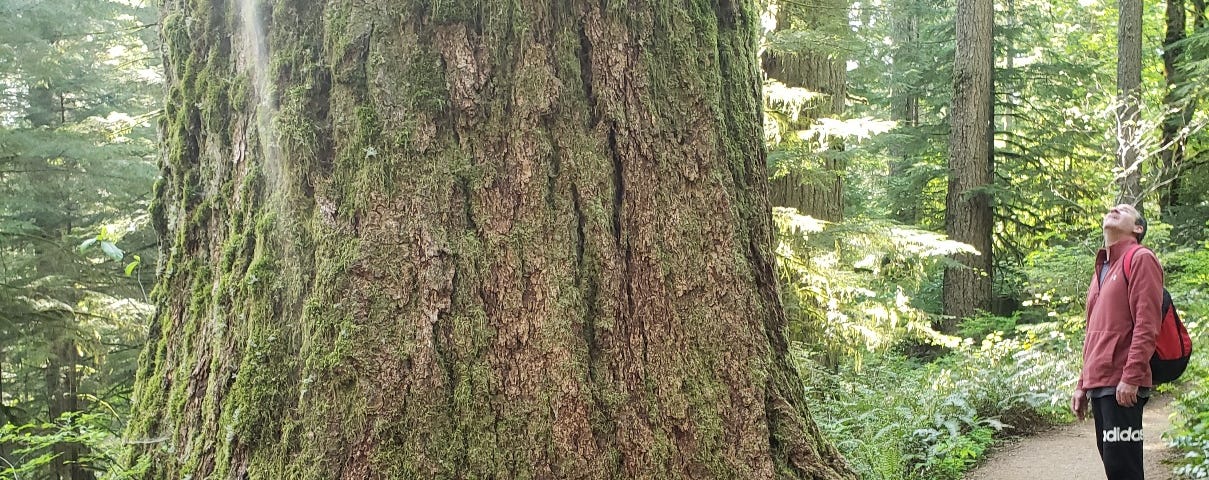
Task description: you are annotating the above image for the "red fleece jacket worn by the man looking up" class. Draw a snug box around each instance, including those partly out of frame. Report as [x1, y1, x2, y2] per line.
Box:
[1078, 237, 1163, 389]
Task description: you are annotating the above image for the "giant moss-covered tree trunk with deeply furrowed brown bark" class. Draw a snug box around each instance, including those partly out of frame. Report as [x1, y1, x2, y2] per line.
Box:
[128, 0, 854, 479]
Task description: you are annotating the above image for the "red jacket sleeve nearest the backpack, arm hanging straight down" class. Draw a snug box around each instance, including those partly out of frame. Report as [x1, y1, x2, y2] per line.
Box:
[1121, 249, 1163, 387]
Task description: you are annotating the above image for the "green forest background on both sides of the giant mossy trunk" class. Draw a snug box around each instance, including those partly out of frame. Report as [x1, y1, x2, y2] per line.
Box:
[0, 0, 1209, 480]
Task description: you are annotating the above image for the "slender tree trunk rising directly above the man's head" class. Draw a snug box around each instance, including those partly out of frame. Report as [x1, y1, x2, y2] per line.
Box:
[1117, 0, 1143, 213]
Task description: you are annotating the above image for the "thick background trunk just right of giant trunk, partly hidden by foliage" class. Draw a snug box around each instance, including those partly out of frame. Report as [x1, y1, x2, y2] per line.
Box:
[762, 0, 849, 221]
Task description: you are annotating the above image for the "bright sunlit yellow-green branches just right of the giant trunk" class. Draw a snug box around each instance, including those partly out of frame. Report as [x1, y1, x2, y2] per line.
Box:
[773, 208, 973, 370]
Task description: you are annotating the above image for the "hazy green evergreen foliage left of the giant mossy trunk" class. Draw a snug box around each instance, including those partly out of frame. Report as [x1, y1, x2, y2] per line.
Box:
[0, 0, 160, 479]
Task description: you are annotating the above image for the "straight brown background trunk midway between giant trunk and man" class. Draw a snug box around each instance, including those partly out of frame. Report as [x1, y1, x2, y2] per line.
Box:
[942, 0, 994, 330]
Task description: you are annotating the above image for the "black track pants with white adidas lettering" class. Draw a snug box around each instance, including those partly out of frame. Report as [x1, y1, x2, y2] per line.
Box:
[1092, 395, 1147, 480]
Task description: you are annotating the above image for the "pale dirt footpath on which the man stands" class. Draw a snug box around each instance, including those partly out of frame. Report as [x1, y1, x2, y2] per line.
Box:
[966, 395, 1174, 480]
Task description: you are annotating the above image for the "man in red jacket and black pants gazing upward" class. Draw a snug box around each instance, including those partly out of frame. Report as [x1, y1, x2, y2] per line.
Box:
[1070, 204, 1163, 480]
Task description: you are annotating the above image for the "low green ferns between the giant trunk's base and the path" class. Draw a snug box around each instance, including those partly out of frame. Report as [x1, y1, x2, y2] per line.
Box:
[796, 323, 1081, 480]
